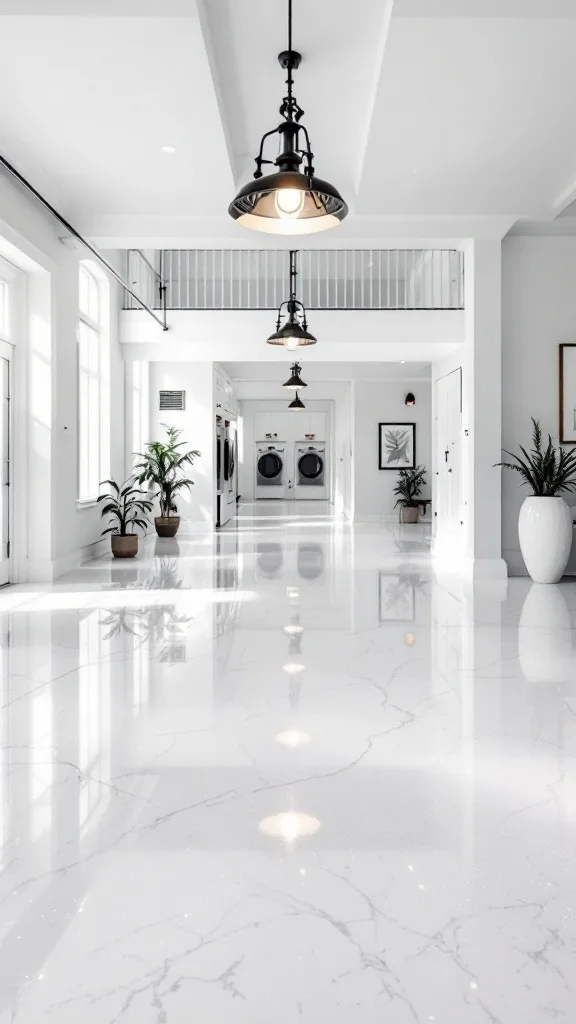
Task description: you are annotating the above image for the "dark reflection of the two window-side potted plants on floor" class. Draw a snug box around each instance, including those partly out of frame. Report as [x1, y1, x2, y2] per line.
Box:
[100, 558, 194, 662]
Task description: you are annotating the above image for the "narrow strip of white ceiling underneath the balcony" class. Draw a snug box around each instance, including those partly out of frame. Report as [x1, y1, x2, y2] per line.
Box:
[221, 362, 430, 386]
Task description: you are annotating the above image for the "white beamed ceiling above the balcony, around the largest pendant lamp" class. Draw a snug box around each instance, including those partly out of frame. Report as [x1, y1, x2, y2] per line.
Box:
[0, 0, 576, 239]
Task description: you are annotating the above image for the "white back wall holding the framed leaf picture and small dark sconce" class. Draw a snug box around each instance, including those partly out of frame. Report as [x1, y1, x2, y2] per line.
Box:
[353, 378, 431, 519]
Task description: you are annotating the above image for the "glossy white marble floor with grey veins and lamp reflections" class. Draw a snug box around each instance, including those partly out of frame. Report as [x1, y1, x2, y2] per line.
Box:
[0, 504, 576, 1024]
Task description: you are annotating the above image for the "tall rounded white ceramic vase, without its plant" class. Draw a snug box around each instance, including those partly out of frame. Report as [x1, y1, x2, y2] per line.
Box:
[518, 496, 572, 583]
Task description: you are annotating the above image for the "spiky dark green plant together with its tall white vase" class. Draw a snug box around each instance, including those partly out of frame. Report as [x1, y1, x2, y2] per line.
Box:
[497, 418, 576, 583]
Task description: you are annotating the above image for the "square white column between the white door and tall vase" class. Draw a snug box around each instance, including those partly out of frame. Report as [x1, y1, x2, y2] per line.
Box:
[462, 239, 506, 580]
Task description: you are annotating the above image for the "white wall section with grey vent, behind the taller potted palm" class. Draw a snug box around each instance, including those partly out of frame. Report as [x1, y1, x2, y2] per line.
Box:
[150, 362, 216, 530]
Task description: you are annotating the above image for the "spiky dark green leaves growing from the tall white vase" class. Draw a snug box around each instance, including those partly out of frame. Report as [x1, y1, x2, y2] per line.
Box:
[496, 417, 576, 498]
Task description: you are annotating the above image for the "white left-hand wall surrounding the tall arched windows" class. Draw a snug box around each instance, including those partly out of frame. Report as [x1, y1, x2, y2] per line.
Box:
[0, 175, 124, 582]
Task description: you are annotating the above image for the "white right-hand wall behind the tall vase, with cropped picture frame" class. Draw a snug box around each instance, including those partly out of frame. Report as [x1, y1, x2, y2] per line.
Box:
[502, 236, 576, 574]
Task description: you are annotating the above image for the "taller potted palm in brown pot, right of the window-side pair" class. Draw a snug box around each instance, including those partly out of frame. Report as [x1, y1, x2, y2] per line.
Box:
[134, 424, 200, 537]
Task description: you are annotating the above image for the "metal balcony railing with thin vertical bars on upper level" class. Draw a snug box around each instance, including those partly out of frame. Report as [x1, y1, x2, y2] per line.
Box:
[124, 249, 464, 309]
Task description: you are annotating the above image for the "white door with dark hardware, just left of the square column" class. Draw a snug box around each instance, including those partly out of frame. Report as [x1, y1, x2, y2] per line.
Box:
[435, 369, 462, 534]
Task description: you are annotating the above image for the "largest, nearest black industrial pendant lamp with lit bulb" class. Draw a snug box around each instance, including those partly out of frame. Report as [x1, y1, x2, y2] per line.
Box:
[229, 0, 348, 234]
